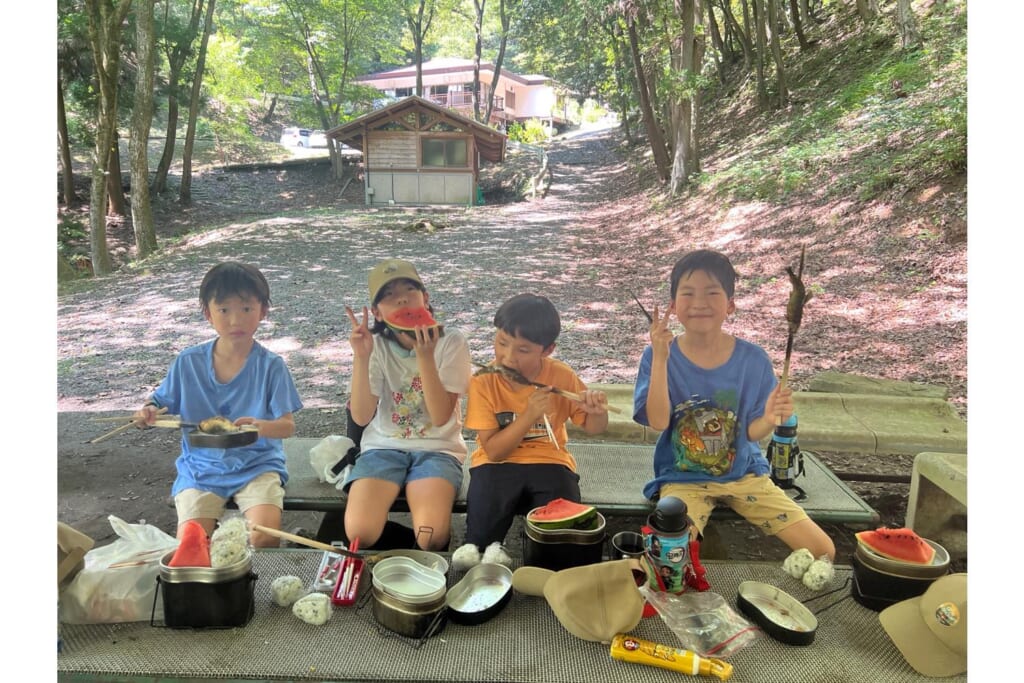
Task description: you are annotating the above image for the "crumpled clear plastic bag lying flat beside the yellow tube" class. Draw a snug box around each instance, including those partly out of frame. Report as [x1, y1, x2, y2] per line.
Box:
[640, 586, 758, 658]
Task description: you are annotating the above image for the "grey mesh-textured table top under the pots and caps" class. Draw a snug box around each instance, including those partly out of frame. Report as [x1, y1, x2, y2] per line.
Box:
[57, 549, 954, 683]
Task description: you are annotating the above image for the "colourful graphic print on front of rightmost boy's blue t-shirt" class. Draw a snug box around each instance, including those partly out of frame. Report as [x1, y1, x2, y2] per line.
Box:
[672, 398, 736, 476]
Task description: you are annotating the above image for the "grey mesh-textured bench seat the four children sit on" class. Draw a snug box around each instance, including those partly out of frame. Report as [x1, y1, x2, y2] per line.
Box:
[285, 437, 879, 524]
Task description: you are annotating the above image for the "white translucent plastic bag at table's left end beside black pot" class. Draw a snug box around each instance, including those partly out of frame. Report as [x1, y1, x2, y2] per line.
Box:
[58, 515, 178, 624]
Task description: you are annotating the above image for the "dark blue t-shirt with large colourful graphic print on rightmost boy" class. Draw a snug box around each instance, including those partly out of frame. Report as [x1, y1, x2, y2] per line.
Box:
[633, 339, 777, 498]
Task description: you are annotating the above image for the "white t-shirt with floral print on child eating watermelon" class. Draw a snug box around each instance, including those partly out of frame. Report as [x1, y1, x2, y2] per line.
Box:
[359, 328, 472, 463]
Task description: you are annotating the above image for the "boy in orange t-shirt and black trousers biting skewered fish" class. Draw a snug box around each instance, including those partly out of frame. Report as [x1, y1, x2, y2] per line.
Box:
[452, 294, 608, 569]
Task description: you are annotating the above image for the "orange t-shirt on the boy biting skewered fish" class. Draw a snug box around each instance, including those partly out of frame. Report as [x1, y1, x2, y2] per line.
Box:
[465, 357, 587, 472]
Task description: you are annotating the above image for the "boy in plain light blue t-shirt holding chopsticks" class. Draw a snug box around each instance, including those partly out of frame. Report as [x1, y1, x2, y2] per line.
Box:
[134, 262, 302, 547]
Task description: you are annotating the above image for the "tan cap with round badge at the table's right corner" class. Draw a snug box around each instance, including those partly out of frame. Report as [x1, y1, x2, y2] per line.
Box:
[879, 572, 967, 677]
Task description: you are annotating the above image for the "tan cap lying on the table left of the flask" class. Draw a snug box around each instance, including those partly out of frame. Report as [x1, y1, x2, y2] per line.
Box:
[512, 559, 644, 643]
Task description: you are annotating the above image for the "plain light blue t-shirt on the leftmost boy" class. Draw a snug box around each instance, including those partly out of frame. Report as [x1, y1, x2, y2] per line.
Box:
[152, 340, 302, 498]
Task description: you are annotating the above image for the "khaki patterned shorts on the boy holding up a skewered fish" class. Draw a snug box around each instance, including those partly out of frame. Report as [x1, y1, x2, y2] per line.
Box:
[660, 474, 808, 536]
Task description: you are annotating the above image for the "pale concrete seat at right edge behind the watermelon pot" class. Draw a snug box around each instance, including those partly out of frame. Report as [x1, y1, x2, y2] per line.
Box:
[905, 453, 967, 557]
